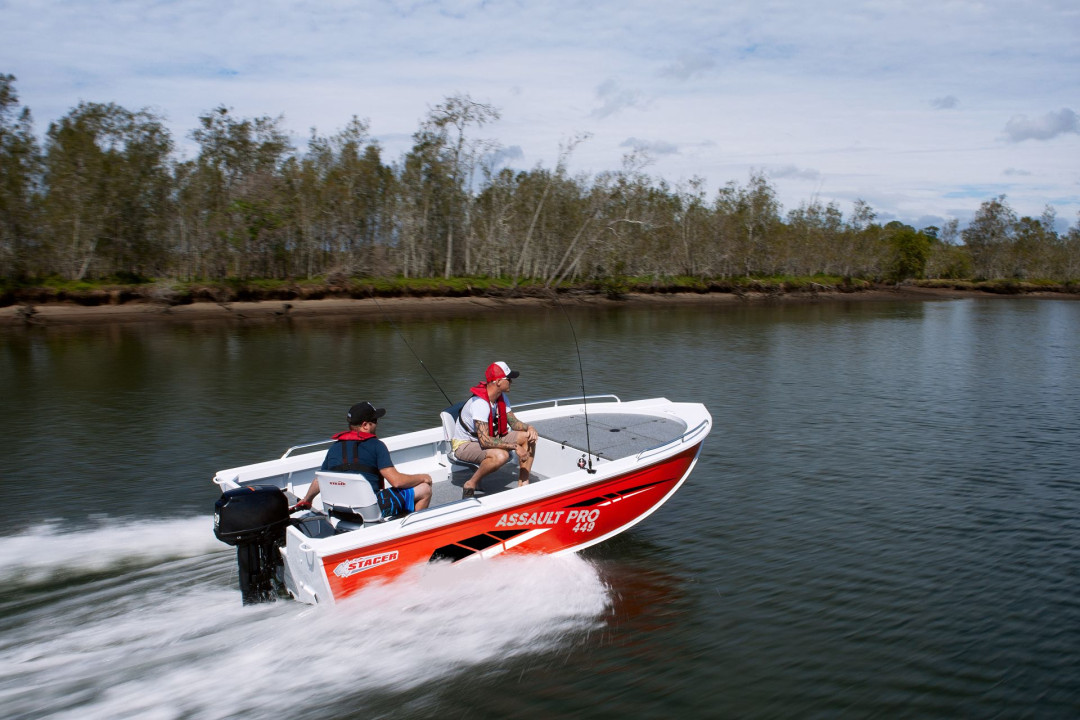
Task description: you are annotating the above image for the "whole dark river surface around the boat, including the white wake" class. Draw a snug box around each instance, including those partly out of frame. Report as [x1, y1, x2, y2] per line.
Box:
[0, 299, 1080, 719]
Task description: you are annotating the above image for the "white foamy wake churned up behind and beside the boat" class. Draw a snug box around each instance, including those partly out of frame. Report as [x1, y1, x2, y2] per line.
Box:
[0, 518, 609, 718]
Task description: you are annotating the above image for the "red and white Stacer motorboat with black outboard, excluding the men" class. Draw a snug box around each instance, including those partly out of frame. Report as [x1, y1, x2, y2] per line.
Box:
[214, 395, 713, 604]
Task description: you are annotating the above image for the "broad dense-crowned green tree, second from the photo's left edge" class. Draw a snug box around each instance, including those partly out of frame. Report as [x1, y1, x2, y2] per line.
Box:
[43, 103, 173, 280]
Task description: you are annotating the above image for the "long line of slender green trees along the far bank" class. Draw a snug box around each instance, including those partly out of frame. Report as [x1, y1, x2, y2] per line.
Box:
[0, 74, 1080, 285]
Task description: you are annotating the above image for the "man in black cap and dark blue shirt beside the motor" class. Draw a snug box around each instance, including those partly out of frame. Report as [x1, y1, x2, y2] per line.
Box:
[293, 402, 431, 513]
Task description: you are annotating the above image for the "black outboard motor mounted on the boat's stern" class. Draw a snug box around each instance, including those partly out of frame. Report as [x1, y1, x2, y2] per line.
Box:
[214, 485, 289, 604]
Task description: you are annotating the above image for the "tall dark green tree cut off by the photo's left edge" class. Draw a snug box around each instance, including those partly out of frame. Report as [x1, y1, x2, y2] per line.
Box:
[0, 73, 41, 280]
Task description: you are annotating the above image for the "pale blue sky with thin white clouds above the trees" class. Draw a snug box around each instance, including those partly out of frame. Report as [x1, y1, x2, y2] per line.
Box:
[0, 0, 1080, 229]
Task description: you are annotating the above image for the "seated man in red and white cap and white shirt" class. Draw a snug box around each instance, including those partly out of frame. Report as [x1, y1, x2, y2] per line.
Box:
[450, 362, 539, 498]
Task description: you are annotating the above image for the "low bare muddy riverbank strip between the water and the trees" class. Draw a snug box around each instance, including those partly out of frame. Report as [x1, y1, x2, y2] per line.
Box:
[0, 286, 1080, 327]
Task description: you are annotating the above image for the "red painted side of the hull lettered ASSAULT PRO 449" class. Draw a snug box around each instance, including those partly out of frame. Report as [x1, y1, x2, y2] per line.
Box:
[323, 443, 701, 599]
